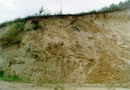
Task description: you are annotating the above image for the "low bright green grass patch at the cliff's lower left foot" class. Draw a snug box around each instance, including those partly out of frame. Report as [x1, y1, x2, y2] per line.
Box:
[0, 70, 23, 82]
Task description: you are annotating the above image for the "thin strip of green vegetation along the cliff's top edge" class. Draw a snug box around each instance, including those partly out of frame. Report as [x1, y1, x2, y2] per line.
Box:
[0, 0, 130, 28]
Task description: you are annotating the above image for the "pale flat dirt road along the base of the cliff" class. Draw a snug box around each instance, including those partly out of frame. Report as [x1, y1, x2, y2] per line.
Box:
[0, 81, 130, 90]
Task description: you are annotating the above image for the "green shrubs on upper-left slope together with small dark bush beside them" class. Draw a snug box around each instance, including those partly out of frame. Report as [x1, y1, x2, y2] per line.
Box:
[0, 21, 41, 47]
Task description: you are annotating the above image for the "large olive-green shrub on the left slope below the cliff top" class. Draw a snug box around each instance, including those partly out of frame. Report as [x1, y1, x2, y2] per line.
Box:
[0, 23, 24, 47]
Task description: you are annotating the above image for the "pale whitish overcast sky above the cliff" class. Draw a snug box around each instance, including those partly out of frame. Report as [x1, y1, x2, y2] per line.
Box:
[0, 0, 125, 23]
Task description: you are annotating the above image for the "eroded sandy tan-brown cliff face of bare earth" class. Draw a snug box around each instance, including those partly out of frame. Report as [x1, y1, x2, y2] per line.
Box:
[0, 10, 130, 83]
